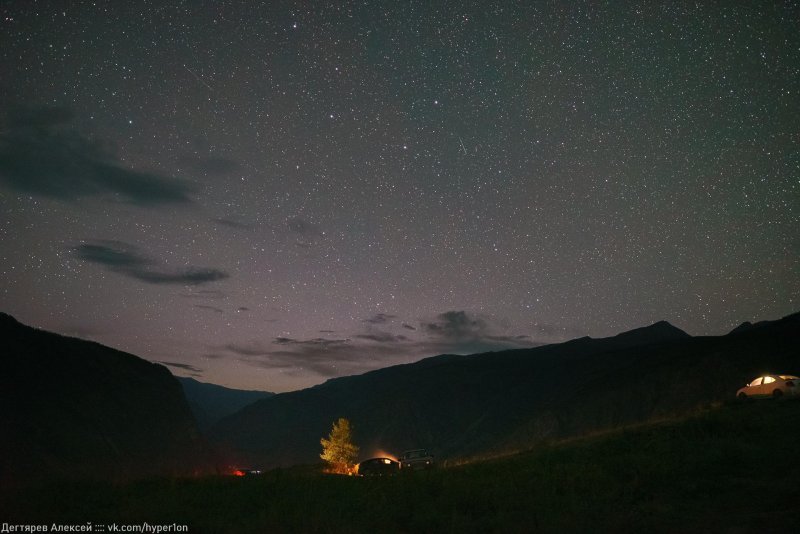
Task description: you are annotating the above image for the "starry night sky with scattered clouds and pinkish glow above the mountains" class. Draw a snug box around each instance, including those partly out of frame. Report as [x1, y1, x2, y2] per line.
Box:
[0, 0, 800, 391]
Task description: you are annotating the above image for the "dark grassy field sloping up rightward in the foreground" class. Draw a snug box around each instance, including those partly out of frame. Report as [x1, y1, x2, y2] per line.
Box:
[0, 400, 800, 533]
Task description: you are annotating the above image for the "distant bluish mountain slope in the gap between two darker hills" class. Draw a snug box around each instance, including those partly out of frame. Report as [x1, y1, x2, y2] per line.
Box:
[175, 376, 274, 430]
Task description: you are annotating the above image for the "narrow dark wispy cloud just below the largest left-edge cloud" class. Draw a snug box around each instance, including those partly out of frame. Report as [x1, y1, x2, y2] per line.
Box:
[72, 241, 228, 285]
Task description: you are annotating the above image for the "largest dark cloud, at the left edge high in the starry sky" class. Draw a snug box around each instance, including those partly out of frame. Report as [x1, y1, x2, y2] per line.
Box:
[0, 107, 191, 205]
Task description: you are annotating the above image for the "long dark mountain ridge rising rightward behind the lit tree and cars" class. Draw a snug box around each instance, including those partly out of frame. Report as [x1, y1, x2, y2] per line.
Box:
[212, 315, 800, 472]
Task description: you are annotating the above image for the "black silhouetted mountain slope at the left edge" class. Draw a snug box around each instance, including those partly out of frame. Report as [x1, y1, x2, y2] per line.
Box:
[0, 314, 216, 484]
